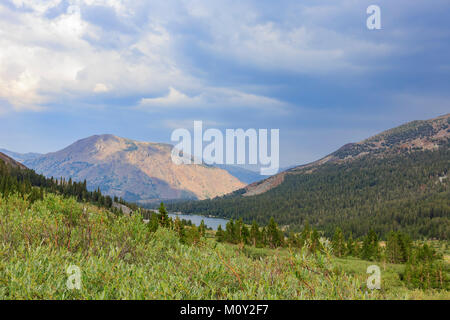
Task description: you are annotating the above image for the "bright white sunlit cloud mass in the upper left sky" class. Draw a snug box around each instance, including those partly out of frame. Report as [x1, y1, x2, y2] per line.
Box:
[0, 0, 193, 111]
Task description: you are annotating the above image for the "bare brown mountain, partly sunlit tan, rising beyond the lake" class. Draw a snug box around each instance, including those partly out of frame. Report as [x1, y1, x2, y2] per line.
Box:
[24, 134, 245, 204]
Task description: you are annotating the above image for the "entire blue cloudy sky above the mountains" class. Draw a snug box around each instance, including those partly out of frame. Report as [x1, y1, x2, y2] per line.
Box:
[0, 0, 450, 166]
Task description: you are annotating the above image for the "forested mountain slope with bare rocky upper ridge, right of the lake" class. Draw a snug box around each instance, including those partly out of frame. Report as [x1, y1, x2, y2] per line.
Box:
[170, 114, 450, 239]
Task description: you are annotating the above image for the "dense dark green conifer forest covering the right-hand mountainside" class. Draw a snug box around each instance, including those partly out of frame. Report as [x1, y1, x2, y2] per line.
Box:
[169, 143, 450, 239]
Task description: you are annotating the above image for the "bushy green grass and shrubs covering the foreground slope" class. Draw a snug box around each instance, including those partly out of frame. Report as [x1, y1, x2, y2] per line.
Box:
[0, 194, 450, 299]
